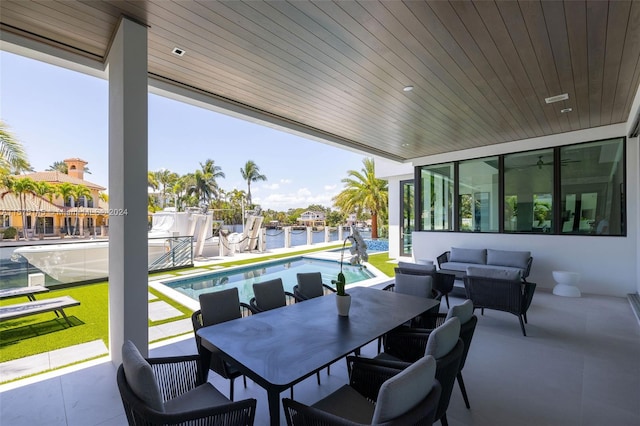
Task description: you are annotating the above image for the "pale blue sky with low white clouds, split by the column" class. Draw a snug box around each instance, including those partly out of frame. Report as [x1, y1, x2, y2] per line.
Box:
[0, 52, 365, 211]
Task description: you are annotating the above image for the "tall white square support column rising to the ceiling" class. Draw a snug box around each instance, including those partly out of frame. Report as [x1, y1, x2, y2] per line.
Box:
[107, 18, 149, 365]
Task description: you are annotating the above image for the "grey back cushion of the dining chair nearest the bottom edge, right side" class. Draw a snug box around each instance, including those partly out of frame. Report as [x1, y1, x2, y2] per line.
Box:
[371, 356, 436, 424]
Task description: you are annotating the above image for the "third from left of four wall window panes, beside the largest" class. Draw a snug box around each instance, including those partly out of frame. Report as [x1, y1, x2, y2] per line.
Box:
[504, 149, 554, 232]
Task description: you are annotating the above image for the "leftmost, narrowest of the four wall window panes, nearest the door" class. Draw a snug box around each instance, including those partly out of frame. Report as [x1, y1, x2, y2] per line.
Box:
[420, 163, 454, 231]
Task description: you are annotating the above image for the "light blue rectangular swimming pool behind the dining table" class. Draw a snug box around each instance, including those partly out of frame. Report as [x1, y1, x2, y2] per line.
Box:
[164, 257, 375, 303]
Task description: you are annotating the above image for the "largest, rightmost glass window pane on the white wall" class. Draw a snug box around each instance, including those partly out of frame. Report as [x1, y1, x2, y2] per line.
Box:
[560, 138, 625, 235]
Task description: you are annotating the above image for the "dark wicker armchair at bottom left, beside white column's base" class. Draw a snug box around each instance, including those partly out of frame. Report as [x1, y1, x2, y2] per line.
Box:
[116, 342, 256, 426]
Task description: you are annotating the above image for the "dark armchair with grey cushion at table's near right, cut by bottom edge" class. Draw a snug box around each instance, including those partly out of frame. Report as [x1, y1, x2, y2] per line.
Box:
[282, 356, 441, 426]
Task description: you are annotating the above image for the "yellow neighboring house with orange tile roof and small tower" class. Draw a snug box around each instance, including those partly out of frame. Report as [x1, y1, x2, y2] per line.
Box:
[0, 158, 109, 236]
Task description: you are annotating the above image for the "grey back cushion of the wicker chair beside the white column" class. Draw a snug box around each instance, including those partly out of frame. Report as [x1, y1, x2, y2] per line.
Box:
[122, 340, 164, 412]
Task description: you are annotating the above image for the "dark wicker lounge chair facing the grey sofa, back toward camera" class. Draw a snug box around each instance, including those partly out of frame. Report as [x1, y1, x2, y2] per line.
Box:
[464, 268, 536, 336]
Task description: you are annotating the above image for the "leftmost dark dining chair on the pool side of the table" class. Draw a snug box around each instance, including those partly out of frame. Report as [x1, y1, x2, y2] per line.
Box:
[191, 288, 253, 401]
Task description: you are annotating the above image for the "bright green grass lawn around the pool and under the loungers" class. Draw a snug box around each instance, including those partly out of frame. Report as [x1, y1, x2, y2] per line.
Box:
[0, 245, 395, 380]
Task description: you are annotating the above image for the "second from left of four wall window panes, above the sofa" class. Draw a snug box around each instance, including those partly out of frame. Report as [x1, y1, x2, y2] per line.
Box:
[458, 157, 499, 232]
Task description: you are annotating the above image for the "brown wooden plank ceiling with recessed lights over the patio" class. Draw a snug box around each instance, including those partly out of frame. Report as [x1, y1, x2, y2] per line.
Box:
[0, 0, 640, 160]
